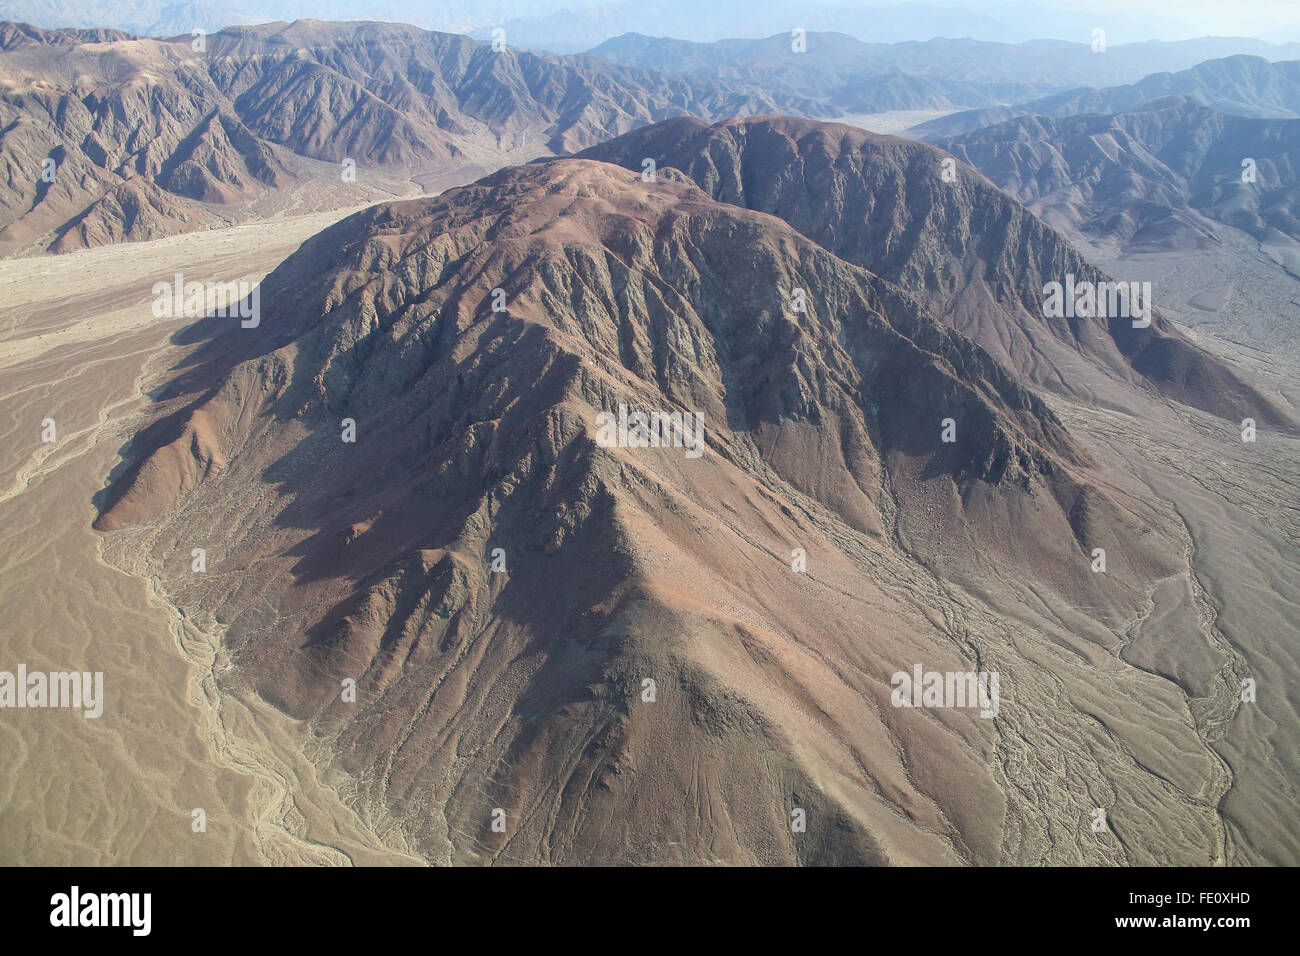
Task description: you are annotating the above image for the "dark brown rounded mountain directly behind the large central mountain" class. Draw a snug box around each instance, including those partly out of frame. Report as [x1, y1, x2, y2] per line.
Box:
[581, 117, 1295, 429]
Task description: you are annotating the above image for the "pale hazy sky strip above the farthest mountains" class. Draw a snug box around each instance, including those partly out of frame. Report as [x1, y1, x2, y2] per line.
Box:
[0, 0, 1300, 53]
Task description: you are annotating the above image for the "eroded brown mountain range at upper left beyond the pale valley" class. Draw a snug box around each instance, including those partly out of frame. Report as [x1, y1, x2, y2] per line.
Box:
[0, 21, 815, 254]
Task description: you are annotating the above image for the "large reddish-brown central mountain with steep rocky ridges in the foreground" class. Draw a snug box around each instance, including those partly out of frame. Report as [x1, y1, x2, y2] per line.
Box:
[99, 160, 1208, 862]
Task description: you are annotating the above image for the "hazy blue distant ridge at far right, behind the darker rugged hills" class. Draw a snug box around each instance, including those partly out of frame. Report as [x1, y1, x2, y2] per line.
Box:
[910, 56, 1300, 139]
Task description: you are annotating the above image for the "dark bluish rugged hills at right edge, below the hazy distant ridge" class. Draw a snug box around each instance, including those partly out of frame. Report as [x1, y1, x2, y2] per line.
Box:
[936, 97, 1300, 278]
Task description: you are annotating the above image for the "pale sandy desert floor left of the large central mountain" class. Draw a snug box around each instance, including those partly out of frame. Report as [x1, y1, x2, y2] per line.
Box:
[0, 211, 420, 865]
